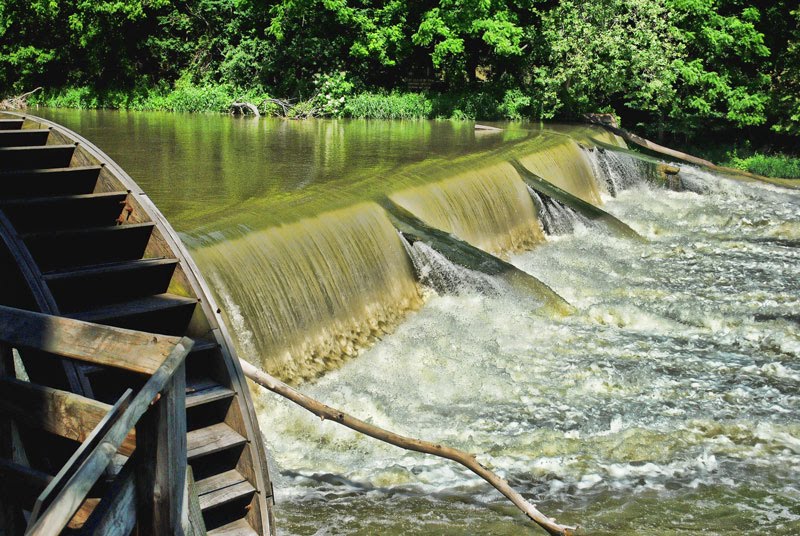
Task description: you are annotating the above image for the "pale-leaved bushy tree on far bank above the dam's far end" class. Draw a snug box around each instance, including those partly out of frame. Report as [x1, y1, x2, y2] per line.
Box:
[531, 0, 682, 118]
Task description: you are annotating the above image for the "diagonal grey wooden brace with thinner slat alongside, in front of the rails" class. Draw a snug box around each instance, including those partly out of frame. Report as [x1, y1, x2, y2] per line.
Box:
[28, 337, 193, 536]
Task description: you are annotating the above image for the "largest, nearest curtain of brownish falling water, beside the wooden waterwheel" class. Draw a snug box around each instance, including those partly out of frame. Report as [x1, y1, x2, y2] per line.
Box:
[194, 203, 421, 381]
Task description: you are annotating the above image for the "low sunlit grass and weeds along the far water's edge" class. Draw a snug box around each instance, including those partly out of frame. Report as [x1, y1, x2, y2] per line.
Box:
[21, 83, 800, 179]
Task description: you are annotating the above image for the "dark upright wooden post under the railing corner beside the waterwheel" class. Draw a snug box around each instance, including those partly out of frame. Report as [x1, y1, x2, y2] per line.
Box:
[136, 364, 186, 534]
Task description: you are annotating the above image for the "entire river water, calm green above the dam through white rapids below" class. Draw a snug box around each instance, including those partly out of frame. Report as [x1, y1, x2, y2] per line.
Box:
[33, 110, 800, 535]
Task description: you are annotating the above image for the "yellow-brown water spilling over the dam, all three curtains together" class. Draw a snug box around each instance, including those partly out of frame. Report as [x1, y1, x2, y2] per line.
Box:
[194, 134, 620, 382]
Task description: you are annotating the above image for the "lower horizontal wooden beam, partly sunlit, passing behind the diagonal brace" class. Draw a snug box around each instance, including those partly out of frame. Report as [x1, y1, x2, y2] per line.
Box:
[0, 378, 136, 456]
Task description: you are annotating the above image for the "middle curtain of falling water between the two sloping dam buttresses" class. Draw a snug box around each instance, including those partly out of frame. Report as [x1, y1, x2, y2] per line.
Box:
[389, 162, 544, 256]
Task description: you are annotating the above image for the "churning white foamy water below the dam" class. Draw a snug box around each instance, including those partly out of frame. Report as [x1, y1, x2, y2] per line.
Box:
[252, 168, 800, 535]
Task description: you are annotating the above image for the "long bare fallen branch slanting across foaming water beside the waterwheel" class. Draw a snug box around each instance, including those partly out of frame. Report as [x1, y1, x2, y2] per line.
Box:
[239, 359, 575, 536]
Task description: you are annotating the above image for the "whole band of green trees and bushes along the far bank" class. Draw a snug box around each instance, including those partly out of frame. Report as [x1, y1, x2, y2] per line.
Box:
[0, 0, 800, 145]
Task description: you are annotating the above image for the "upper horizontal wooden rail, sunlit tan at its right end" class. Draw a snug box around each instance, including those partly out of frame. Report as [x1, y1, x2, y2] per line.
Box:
[0, 306, 180, 374]
